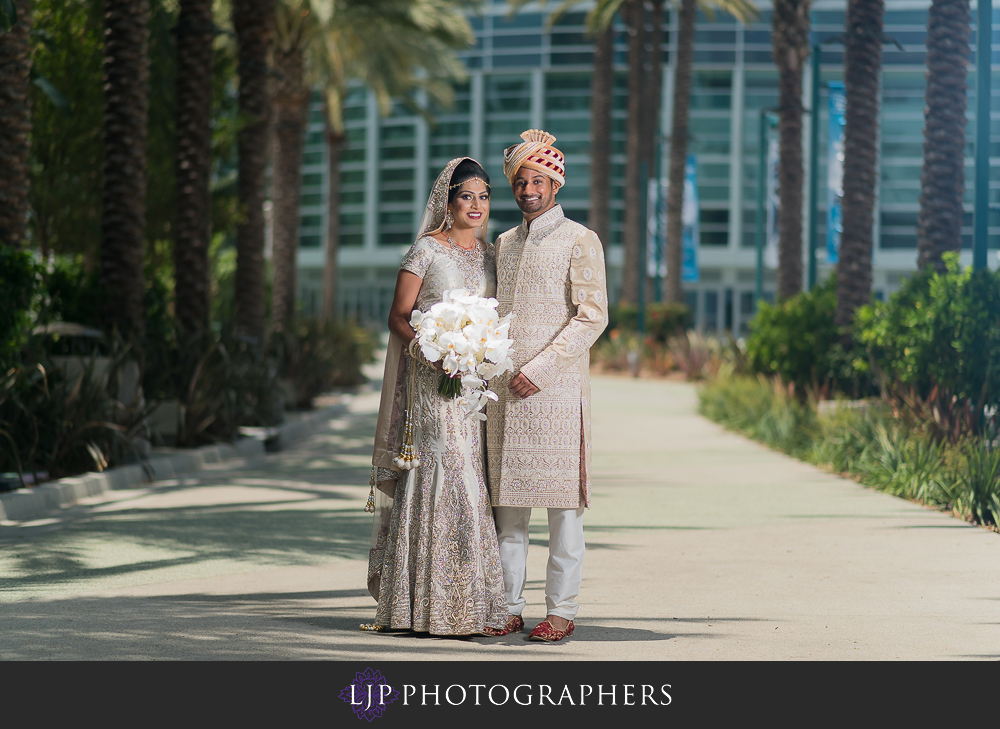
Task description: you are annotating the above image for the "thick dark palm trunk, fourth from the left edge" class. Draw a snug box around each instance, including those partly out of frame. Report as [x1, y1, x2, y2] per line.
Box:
[233, 0, 275, 341]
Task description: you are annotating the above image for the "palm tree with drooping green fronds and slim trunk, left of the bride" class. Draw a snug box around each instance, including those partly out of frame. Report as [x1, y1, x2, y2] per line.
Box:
[308, 0, 474, 318]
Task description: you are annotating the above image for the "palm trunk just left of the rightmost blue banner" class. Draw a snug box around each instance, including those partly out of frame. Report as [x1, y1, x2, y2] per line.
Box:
[771, 0, 809, 299]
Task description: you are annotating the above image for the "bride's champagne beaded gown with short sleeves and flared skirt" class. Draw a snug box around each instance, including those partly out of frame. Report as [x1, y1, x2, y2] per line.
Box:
[368, 161, 508, 635]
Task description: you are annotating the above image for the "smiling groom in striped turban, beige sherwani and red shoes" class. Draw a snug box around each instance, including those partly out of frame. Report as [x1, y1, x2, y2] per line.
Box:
[486, 129, 608, 641]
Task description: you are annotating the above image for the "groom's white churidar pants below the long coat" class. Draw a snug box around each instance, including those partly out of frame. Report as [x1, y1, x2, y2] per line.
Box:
[493, 506, 586, 620]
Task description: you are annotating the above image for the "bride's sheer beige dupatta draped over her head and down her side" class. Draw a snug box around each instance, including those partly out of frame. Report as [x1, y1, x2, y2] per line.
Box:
[368, 157, 489, 600]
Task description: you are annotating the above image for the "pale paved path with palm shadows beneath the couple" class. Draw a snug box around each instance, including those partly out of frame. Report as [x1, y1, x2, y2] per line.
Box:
[0, 377, 1000, 660]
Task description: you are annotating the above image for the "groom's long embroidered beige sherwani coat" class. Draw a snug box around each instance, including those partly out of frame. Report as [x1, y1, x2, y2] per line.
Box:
[486, 205, 608, 509]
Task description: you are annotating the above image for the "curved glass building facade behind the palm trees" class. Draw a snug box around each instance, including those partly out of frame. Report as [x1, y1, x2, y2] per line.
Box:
[298, 0, 1000, 334]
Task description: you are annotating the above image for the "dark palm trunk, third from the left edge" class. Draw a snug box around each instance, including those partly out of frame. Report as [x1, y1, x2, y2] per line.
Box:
[174, 0, 215, 334]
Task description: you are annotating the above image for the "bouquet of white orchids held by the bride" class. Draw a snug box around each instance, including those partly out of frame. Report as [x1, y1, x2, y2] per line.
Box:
[410, 289, 514, 420]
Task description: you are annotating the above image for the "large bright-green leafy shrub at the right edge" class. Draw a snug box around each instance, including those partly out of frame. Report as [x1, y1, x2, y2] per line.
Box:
[856, 253, 1000, 436]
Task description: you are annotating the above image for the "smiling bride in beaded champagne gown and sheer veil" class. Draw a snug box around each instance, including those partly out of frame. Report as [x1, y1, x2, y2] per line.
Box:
[362, 157, 508, 635]
